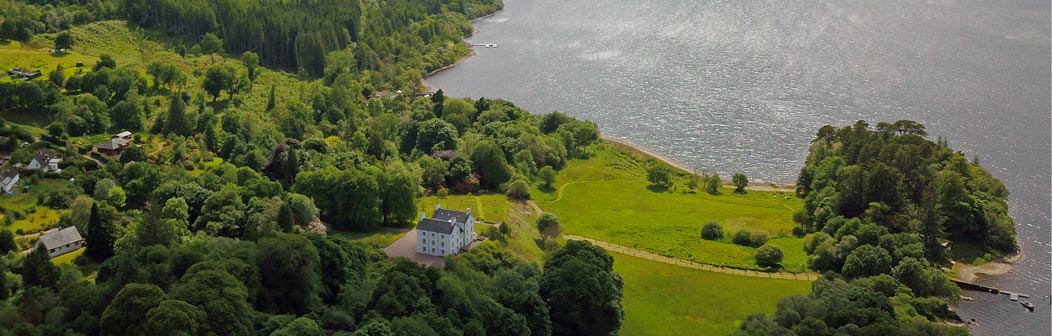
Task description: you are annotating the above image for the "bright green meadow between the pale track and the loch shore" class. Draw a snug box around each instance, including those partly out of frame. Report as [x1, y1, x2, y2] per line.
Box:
[532, 144, 807, 272]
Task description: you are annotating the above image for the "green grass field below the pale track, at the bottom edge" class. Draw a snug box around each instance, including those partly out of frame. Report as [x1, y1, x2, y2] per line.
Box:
[610, 253, 811, 335]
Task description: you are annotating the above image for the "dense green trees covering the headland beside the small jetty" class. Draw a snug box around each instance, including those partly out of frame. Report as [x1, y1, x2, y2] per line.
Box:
[740, 120, 1017, 335]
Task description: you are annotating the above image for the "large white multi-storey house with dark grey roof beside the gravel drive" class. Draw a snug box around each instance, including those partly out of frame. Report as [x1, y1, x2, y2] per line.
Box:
[417, 205, 474, 256]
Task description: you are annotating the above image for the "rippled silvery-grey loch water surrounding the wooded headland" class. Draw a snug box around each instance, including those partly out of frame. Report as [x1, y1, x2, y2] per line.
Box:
[427, 0, 1052, 335]
